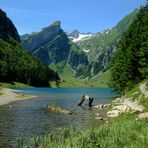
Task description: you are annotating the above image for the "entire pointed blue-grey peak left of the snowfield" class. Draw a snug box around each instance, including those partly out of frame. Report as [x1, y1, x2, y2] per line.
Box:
[22, 21, 70, 65]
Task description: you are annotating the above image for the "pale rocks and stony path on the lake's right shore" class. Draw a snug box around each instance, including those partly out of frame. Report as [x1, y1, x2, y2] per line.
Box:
[94, 82, 148, 120]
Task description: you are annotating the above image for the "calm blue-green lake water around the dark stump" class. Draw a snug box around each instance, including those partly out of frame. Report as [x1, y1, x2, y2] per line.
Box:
[0, 88, 116, 147]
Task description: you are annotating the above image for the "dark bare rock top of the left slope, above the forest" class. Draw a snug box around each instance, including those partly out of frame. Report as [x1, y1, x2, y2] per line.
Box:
[0, 9, 20, 42]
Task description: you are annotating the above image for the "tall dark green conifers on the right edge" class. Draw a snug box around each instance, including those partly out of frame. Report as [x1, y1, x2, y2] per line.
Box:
[111, 5, 148, 91]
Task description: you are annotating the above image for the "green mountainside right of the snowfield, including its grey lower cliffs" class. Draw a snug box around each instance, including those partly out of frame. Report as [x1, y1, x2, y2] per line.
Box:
[79, 9, 139, 75]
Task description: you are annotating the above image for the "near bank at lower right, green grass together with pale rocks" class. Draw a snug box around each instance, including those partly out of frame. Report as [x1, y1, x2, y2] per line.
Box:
[16, 82, 148, 148]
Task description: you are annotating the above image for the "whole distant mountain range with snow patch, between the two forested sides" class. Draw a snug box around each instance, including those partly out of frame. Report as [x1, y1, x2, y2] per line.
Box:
[21, 9, 139, 81]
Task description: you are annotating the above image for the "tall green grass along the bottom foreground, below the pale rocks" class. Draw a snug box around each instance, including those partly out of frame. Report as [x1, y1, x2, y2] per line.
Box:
[17, 114, 148, 148]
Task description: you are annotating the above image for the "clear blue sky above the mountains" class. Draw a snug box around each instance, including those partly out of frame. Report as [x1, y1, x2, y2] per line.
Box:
[0, 0, 146, 34]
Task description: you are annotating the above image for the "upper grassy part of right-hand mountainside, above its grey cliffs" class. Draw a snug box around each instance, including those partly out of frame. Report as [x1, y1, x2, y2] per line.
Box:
[79, 10, 138, 62]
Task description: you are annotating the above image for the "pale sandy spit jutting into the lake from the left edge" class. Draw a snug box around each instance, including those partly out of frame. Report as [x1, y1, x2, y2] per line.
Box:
[0, 87, 37, 106]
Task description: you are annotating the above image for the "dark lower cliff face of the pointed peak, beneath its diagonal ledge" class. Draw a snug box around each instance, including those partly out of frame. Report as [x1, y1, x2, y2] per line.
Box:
[34, 30, 70, 65]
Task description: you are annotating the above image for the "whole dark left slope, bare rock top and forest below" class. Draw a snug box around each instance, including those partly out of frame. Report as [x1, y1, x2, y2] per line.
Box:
[0, 10, 59, 86]
